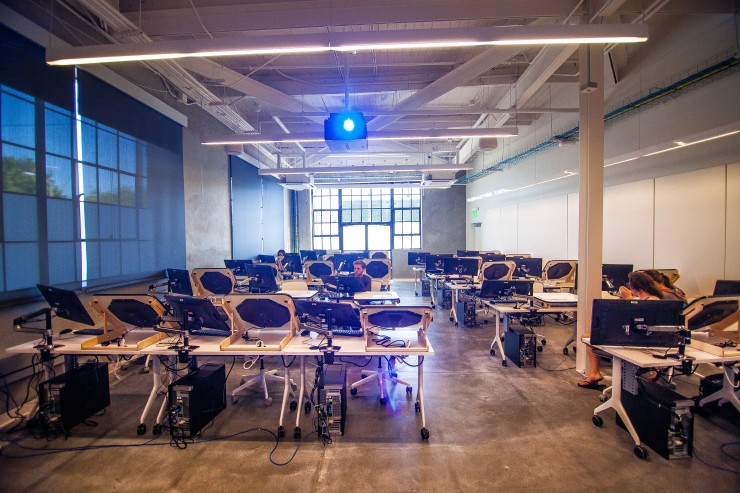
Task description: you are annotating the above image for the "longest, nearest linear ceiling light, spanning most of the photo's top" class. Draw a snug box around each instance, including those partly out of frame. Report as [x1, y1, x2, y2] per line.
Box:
[46, 24, 648, 65]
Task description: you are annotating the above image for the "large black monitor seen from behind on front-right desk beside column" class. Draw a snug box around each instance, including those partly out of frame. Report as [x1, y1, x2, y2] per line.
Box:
[591, 300, 684, 347]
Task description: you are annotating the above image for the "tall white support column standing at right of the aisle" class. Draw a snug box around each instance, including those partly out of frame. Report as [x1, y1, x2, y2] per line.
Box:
[576, 44, 604, 373]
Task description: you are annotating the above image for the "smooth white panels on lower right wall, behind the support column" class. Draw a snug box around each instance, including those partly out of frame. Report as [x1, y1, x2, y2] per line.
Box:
[474, 164, 740, 296]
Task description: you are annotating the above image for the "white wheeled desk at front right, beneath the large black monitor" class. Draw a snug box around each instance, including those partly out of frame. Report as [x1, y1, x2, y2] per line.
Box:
[583, 338, 740, 459]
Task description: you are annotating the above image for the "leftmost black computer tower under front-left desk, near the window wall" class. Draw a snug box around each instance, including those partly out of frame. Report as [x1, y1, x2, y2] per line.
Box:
[39, 363, 110, 434]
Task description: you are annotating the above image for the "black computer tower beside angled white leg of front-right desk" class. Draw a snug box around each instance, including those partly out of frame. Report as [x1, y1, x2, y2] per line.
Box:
[617, 381, 694, 459]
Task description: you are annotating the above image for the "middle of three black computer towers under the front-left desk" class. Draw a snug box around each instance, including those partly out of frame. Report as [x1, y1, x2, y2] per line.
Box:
[168, 363, 226, 438]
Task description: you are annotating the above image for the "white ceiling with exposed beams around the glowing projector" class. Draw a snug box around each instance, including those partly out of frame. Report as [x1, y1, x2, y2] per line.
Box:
[0, 0, 732, 188]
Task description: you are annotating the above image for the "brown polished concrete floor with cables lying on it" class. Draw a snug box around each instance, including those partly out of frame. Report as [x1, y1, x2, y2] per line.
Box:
[0, 281, 740, 492]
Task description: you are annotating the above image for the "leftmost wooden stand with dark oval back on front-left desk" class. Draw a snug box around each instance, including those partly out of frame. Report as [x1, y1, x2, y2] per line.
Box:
[82, 294, 172, 351]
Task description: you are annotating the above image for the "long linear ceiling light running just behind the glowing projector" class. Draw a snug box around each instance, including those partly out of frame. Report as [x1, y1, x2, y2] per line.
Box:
[203, 127, 519, 145]
